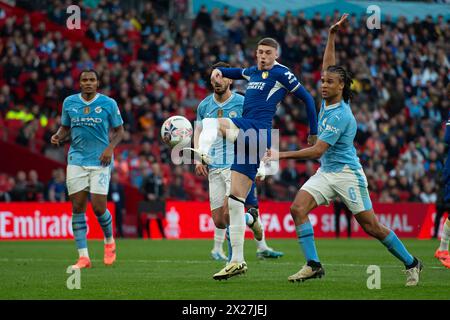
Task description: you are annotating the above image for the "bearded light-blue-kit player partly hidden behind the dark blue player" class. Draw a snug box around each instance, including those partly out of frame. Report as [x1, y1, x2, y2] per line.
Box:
[194, 62, 283, 261]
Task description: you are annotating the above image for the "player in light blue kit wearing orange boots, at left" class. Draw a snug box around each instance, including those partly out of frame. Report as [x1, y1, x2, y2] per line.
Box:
[51, 70, 124, 269]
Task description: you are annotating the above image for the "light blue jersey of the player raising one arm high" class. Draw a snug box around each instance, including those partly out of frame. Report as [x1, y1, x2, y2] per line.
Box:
[318, 100, 361, 172]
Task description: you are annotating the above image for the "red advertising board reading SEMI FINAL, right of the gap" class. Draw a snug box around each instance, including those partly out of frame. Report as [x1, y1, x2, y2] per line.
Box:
[159, 201, 445, 239]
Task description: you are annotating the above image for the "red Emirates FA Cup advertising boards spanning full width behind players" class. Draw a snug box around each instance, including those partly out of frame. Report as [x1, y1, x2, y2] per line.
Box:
[0, 201, 445, 240]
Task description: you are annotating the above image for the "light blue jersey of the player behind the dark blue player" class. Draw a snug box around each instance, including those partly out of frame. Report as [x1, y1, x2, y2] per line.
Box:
[197, 93, 244, 169]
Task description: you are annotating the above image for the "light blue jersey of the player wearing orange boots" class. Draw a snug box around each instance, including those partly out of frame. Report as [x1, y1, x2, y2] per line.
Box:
[61, 93, 123, 166]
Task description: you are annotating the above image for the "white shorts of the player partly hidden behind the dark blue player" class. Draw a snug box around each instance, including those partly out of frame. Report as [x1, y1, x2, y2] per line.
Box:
[208, 168, 231, 211]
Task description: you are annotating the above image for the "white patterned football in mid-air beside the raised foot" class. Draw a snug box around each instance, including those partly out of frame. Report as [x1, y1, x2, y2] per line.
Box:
[161, 116, 193, 148]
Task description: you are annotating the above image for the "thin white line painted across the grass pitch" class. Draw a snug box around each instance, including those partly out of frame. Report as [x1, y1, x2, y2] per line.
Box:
[0, 258, 444, 270]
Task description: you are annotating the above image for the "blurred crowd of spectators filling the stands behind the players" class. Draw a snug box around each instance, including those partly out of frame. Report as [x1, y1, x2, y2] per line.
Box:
[0, 0, 450, 202]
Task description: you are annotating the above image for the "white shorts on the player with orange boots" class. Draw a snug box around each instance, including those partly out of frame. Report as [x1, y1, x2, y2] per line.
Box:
[66, 164, 111, 195]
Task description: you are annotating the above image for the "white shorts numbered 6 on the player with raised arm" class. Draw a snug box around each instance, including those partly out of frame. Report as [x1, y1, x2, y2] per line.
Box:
[300, 166, 372, 214]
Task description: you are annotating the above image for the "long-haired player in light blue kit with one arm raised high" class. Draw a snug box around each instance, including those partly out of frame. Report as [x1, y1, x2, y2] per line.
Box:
[265, 14, 422, 286]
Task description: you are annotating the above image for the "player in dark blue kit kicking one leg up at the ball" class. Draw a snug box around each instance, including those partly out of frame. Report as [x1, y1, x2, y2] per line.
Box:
[188, 38, 317, 280]
